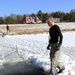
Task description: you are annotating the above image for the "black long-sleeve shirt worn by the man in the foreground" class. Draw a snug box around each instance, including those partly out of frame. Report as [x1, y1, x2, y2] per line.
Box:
[49, 25, 63, 44]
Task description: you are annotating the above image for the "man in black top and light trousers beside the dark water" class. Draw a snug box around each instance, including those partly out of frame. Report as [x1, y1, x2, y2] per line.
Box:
[47, 17, 65, 75]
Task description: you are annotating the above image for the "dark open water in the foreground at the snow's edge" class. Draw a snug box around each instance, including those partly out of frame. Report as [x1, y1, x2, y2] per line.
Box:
[0, 61, 47, 75]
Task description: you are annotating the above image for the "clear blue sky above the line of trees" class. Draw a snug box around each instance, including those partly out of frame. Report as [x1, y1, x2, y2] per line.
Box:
[0, 0, 75, 16]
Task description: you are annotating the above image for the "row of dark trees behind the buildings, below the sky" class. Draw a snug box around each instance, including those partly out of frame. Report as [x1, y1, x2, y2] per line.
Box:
[0, 9, 75, 24]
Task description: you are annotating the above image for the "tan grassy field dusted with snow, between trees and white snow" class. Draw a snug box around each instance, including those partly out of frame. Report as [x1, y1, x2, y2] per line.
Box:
[0, 22, 75, 35]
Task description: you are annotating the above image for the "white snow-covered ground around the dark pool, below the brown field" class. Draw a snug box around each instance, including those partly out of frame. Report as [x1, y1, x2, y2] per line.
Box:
[0, 31, 75, 75]
